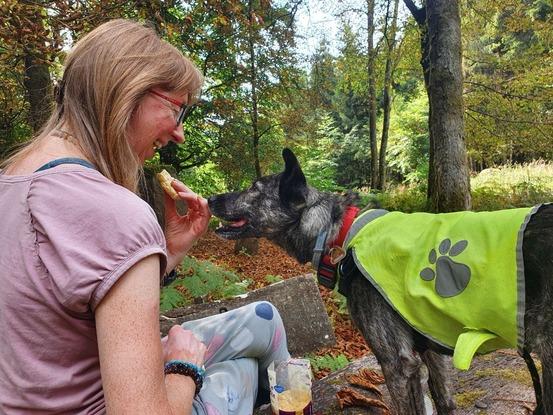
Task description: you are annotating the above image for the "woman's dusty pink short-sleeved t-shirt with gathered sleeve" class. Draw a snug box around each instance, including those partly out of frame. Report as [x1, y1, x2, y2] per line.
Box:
[0, 165, 165, 414]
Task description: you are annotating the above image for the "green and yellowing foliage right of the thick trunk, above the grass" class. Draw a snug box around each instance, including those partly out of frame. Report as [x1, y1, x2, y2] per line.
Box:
[462, 0, 553, 169]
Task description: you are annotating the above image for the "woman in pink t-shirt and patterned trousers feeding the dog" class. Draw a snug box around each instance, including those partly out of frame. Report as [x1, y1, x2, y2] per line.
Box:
[0, 20, 289, 414]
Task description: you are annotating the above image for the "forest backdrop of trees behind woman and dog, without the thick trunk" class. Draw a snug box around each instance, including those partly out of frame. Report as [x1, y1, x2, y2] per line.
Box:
[0, 0, 553, 211]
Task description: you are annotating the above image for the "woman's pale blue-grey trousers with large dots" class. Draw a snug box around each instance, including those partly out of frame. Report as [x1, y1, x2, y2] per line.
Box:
[182, 301, 290, 415]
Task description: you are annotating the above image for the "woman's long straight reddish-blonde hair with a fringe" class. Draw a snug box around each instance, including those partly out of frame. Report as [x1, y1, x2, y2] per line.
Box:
[3, 19, 203, 192]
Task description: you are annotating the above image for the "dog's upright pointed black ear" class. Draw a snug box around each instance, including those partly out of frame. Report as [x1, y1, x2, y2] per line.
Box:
[278, 148, 307, 209]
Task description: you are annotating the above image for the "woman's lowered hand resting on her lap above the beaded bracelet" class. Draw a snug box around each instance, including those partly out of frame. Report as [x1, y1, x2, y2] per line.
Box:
[161, 325, 206, 367]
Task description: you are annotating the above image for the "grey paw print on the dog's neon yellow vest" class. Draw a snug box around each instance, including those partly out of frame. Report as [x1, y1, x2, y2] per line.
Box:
[420, 239, 471, 298]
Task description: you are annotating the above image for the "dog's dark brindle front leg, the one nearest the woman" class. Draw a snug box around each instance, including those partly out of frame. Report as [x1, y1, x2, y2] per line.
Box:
[348, 276, 425, 415]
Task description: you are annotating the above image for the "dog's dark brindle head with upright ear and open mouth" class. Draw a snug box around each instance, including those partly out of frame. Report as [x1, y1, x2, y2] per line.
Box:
[209, 149, 309, 239]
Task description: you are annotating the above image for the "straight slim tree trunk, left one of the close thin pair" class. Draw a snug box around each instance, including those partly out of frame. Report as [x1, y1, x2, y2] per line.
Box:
[367, 0, 378, 188]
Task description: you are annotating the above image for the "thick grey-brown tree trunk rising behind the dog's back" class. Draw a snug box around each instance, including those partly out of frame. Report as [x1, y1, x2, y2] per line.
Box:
[426, 0, 471, 212]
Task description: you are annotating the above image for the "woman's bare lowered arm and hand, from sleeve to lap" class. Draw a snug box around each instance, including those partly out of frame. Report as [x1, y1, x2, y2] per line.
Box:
[95, 255, 205, 415]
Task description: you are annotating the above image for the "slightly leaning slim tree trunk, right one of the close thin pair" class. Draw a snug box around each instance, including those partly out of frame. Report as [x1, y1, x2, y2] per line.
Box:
[378, 0, 399, 190]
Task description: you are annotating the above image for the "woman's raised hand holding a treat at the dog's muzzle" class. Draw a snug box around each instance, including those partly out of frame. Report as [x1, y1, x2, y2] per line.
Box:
[165, 179, 211, 271]
